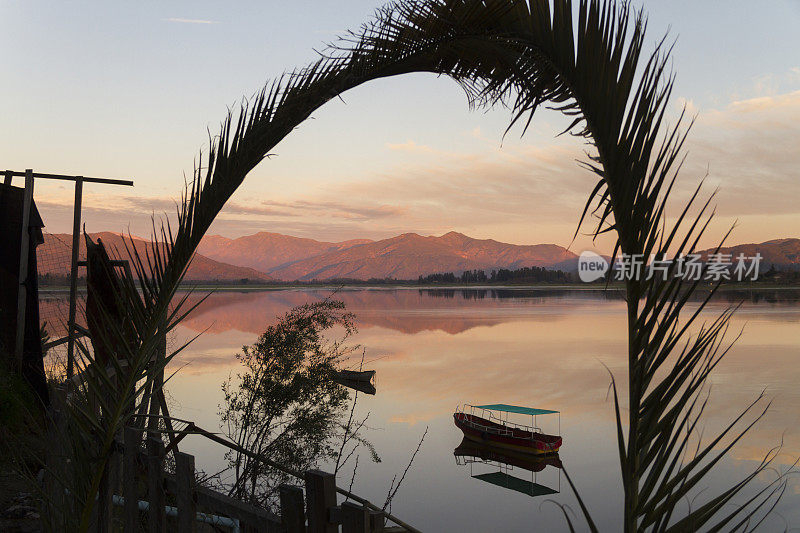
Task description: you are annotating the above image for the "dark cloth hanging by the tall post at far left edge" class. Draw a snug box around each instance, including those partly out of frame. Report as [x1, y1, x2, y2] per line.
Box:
[0, 183, 49, 405]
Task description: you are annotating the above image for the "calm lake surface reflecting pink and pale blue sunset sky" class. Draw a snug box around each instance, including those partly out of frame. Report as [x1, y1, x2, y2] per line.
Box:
[158, 289, 800, 532]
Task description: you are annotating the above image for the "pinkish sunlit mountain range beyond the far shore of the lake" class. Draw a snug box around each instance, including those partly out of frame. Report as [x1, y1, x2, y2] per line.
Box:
[39, 232, 800, 282]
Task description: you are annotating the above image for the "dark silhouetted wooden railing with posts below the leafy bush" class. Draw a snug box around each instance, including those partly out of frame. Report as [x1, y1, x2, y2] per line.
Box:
[97, 427, 413, 533]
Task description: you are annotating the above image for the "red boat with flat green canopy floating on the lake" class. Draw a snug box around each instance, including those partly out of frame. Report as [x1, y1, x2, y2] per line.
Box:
[453, 404, 562, 454]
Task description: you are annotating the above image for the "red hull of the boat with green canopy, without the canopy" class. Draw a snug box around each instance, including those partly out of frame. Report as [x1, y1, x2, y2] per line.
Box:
[453, 413, 561, 454]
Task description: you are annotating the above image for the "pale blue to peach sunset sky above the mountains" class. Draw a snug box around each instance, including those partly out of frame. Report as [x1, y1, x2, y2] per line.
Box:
[0, 0, 800, 252]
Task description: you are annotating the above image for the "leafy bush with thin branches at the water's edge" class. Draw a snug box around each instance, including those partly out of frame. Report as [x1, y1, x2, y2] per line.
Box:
[220, 300, 362, 506]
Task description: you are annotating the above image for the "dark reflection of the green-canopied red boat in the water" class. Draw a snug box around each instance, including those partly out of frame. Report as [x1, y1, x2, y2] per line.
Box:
[453, 438, 561, 497]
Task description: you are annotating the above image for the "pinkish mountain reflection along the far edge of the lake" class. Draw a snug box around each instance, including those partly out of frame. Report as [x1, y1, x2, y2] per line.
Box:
[175, 289, 800, 335]
